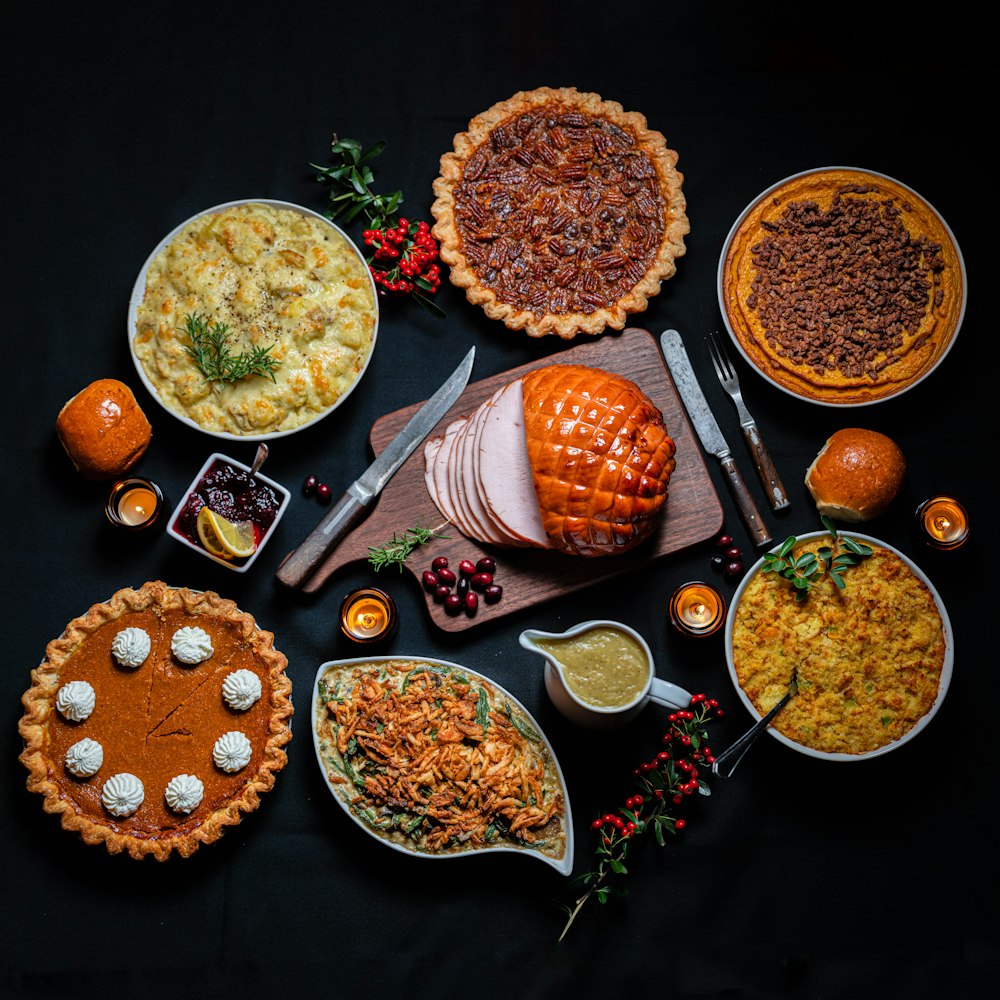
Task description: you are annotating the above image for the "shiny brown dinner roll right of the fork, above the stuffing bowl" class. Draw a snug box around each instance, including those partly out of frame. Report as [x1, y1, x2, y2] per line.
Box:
[806, 427, 906, 521]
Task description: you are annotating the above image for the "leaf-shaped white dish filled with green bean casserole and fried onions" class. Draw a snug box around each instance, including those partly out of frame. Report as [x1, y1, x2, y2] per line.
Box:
[312, 656, 573, 875]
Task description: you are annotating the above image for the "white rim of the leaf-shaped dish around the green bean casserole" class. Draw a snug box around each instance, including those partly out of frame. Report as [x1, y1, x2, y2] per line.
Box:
[310, 656, 573, 875]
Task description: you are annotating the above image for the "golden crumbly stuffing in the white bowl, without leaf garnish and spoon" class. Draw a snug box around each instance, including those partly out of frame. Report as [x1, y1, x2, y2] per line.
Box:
[732, 537, 945, 754]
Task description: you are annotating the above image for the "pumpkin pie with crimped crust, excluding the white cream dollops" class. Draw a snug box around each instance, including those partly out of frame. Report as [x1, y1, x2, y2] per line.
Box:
[18, 581, 293, 861]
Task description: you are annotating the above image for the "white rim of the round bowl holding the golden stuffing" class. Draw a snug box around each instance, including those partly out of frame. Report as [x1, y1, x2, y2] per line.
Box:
[726, 531, 955, 761]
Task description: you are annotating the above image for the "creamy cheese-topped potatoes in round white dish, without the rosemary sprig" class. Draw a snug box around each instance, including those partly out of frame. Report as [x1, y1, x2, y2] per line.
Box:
[133, 203, 378, 436]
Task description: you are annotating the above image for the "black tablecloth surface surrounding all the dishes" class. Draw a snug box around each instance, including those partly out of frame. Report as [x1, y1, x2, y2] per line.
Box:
[0, 2, 997, 998]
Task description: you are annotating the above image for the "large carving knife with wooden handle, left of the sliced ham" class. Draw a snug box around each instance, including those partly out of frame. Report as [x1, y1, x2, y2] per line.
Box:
[275, 347, 476, 588]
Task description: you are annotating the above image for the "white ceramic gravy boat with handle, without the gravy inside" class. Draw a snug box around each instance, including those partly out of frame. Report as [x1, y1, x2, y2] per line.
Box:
[519, 619, 691, 729]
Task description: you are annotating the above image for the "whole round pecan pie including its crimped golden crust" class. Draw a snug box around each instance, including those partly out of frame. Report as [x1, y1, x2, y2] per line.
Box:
[431, 87, 690, 339]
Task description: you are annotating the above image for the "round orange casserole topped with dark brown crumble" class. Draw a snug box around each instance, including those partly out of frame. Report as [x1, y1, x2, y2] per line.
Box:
[719, 167, 965, 405]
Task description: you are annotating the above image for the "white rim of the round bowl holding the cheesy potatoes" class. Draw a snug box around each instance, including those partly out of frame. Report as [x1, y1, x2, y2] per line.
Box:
[126, 198, 379, 441]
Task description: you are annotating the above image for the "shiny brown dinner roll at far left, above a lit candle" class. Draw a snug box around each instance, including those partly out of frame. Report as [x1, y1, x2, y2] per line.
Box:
[56, 378, 152, 479]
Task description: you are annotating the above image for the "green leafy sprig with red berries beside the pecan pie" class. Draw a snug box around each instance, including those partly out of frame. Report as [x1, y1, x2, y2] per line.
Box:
[311, 135, 444, 316]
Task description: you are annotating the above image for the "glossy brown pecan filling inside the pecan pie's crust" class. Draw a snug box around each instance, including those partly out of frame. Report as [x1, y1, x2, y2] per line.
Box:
[455, 103, 667, 316]
